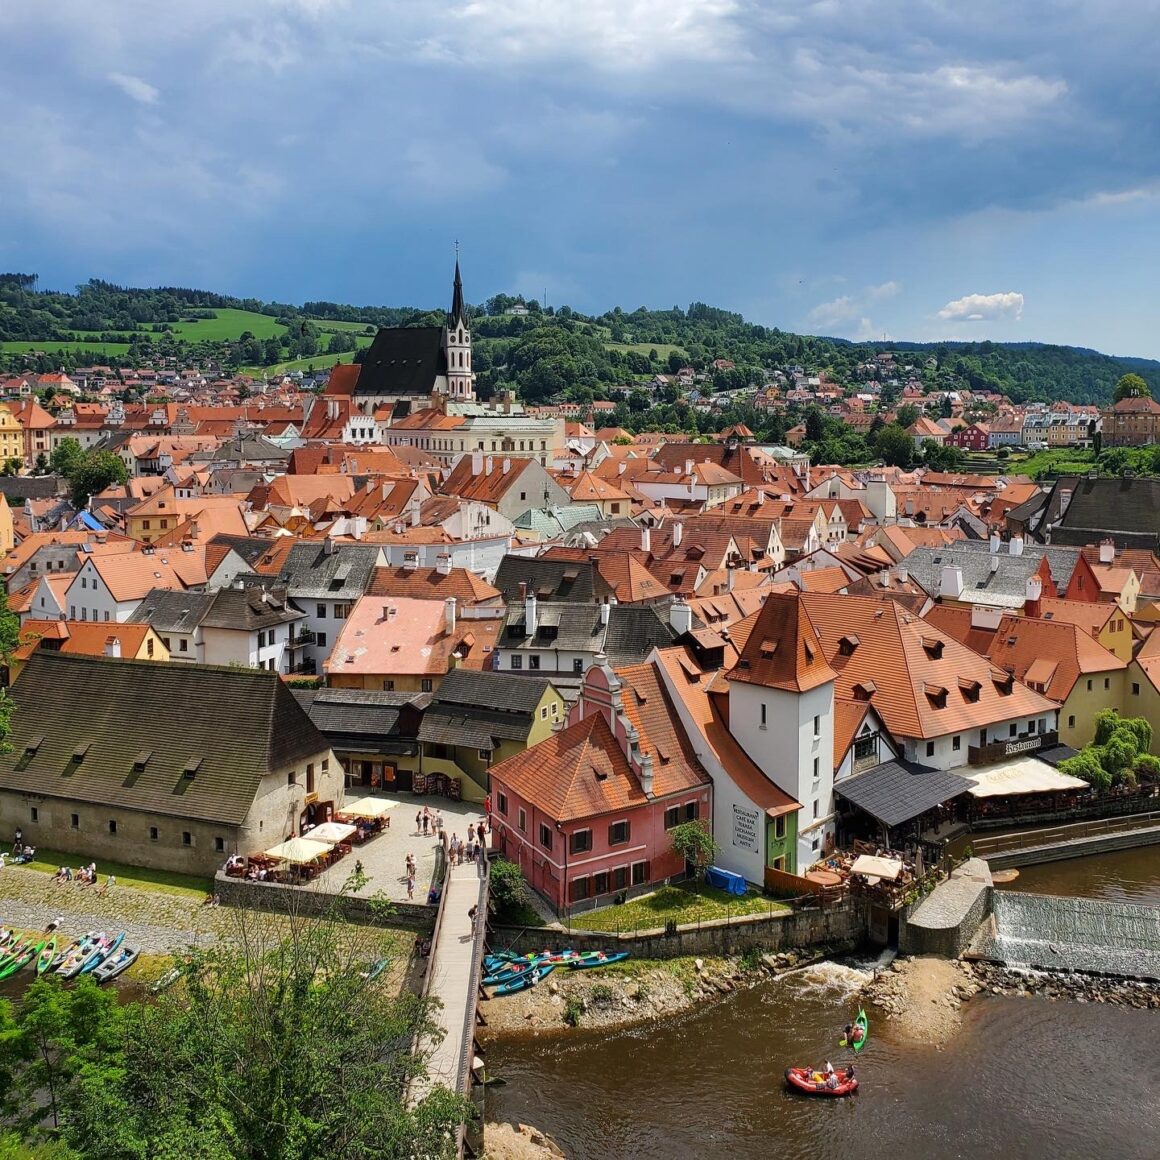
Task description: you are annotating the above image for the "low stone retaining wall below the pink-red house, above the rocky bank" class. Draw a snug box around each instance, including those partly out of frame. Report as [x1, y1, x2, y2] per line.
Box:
[490, 899, 865, 958]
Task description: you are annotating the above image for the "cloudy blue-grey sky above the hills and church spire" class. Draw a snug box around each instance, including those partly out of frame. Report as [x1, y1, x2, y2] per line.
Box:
[0, 0, 1160, 357]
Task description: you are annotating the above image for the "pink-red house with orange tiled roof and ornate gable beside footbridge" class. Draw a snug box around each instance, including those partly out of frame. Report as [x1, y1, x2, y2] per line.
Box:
[491, 665, 712, 912]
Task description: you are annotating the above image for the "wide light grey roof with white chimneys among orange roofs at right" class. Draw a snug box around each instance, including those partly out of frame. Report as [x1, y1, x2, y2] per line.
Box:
[902, 539, 1080, 604]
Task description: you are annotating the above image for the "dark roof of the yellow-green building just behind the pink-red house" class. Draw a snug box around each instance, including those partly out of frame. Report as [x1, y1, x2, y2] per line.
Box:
[419, 669, 551, 749]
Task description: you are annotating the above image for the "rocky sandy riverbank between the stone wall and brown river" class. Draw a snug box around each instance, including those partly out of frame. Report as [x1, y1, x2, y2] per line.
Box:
[480, 948, 827, 1042]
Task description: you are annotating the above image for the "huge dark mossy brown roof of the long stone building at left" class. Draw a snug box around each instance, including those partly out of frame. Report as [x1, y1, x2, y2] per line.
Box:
[0, 651, 329, 836]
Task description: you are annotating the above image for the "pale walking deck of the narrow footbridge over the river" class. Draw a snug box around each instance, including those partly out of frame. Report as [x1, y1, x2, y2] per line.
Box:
[411, 864, 486, 1103]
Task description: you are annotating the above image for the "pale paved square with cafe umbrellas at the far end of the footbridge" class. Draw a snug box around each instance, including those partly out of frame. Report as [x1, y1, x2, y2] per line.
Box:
[223, 793, 484, 904]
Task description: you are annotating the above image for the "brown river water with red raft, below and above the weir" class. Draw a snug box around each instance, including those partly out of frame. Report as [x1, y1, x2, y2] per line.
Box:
[487, 850, 1160, 1160]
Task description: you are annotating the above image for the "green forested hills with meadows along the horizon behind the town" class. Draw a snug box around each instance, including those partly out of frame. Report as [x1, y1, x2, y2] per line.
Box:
[0, 274, 1160, 405]
